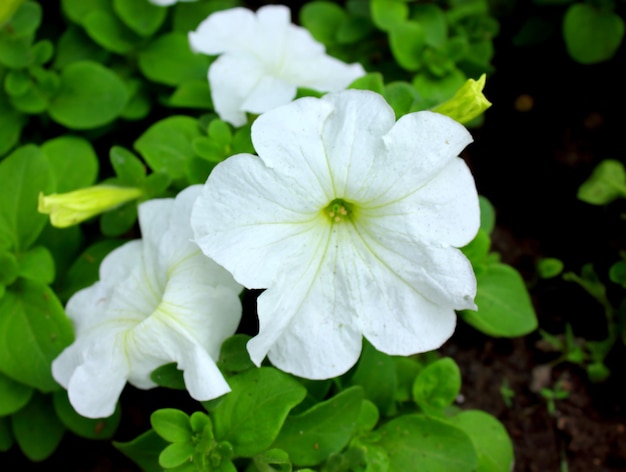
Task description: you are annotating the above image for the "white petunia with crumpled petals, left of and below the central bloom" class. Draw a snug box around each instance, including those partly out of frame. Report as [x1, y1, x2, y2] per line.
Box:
[52, 185, 242, 418]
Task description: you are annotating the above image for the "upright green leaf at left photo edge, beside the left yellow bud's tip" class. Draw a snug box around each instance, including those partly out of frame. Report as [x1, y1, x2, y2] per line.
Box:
[0, 144, 54, 252]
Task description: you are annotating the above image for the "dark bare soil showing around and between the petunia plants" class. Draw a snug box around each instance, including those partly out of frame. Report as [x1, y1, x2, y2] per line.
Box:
[2, 0, 626, 471]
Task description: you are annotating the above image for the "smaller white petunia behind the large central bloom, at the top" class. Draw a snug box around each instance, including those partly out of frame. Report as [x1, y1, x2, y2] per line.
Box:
[189, 5, 365, 126]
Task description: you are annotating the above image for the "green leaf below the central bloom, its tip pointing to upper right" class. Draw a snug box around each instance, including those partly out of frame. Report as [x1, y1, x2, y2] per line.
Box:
[272, 386, 363, 467]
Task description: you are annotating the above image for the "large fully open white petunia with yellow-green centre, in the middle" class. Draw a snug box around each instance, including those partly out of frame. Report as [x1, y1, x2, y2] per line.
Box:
[191, 90, 480, 379]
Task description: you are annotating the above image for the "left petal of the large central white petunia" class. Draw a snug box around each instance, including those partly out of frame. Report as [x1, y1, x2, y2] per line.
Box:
[191, 154, 325, 288]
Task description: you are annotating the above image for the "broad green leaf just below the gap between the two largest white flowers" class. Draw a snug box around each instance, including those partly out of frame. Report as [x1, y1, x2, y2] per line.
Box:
[207, 367, 306, 457]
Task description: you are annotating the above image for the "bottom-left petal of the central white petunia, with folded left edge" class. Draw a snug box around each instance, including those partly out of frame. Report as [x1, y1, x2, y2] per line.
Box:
[247, 227, 362, 379]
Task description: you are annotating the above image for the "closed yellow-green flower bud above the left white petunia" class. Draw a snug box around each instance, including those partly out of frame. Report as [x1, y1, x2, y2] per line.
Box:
[38, 185, 142, 228]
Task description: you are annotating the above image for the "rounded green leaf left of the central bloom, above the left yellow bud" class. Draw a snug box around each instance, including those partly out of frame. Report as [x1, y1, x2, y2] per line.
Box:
[134, 116, 202, 179]
